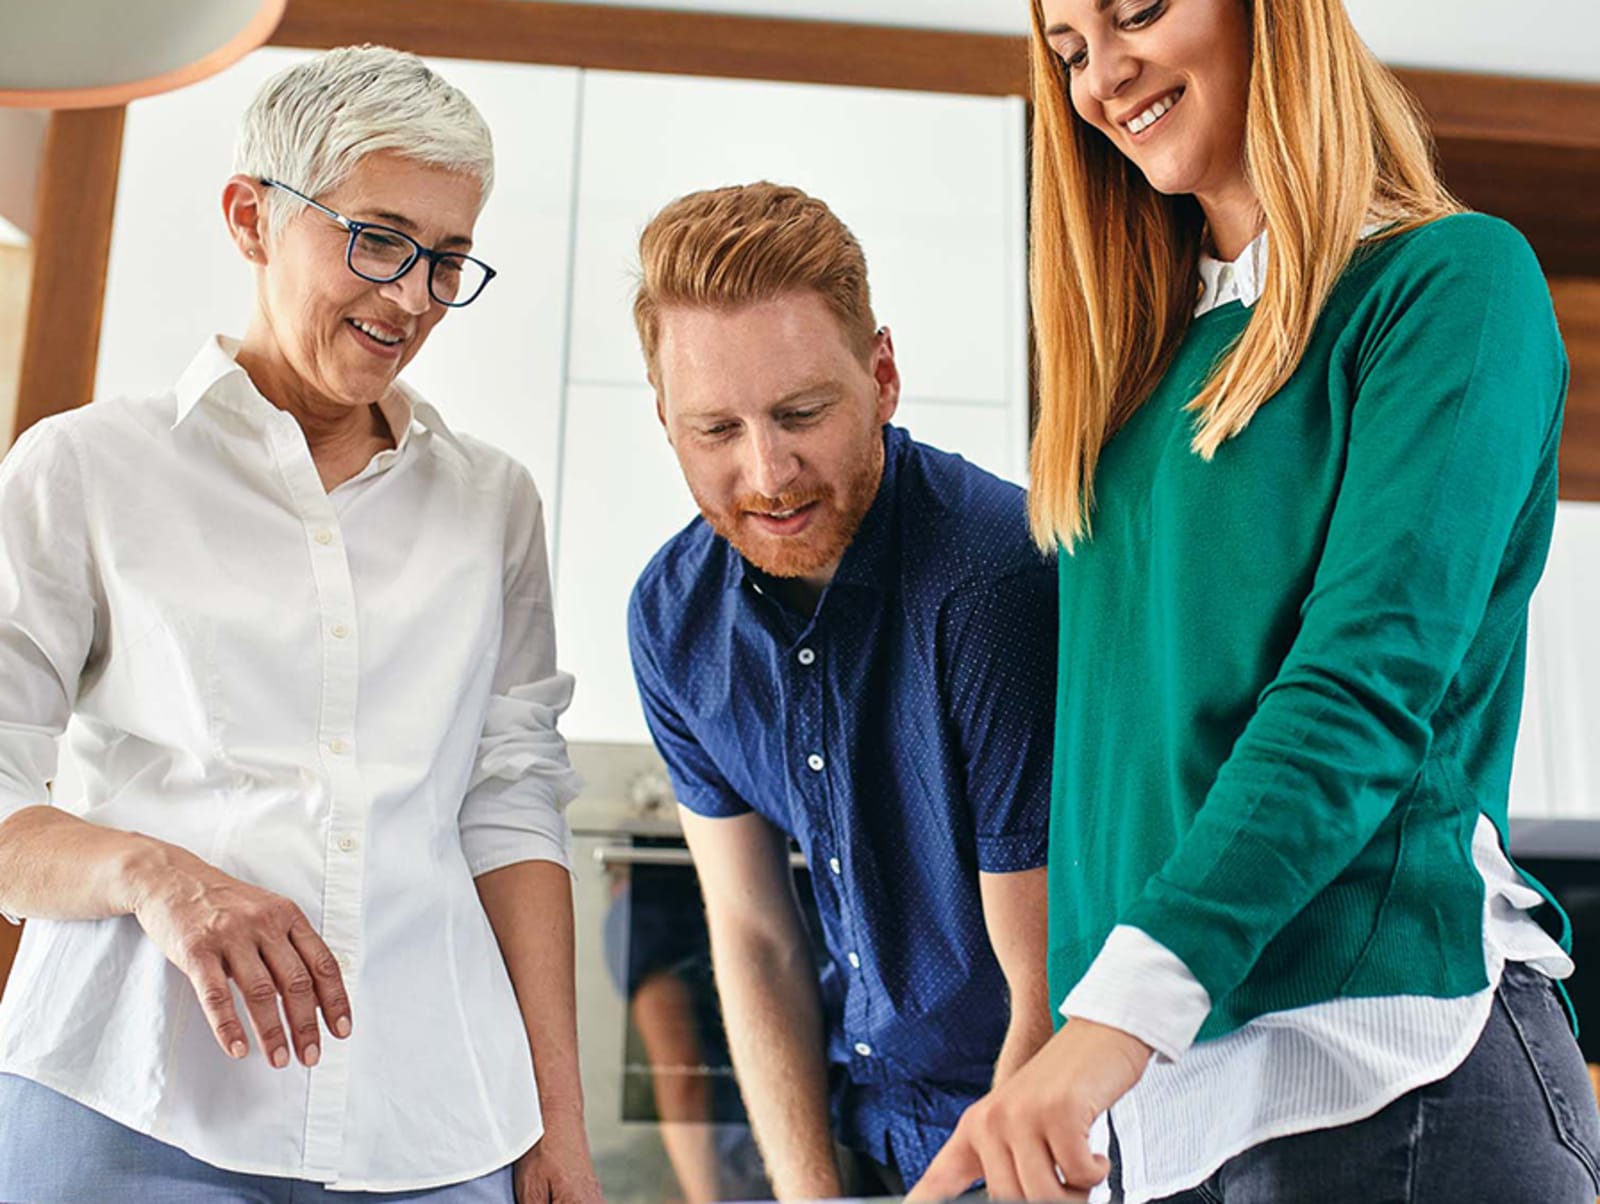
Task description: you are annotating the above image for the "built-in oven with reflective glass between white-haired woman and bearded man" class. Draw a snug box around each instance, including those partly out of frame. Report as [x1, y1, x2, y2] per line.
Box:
[568, 743, 810, 1204]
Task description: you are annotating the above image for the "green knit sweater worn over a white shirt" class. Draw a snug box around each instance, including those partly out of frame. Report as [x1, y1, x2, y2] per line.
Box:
[1050, 215, 1566, 1039]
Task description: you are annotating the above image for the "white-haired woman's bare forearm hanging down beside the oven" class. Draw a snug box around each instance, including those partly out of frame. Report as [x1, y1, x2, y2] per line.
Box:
[477, 861, 584, 1135]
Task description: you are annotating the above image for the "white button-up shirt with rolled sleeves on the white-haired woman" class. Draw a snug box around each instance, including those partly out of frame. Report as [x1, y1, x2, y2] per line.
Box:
[0, 339, 578, 1191]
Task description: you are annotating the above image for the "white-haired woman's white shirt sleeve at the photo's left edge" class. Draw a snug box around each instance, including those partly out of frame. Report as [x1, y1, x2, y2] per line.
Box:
[0, 423, 98, 919]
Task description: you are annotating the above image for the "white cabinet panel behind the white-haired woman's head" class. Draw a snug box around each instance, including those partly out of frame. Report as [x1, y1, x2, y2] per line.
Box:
[96, 48, 579, 522]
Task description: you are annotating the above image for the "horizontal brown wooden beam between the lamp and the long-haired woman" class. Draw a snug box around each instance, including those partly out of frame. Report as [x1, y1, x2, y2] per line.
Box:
[272, 0, 1027, 96]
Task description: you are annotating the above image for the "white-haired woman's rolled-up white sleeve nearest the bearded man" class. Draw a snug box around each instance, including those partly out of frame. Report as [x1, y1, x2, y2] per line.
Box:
[461, 468, 582, 876]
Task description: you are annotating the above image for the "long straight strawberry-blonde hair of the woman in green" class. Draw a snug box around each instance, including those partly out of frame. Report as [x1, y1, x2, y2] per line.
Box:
[1029, 0, 1461, 551]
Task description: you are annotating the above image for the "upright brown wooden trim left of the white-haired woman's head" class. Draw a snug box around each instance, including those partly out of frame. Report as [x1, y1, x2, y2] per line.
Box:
[16, 109, 125, 434]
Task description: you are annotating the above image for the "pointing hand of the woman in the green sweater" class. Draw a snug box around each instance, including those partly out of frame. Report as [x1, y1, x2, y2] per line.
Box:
[907, 1020, 1152, 1201]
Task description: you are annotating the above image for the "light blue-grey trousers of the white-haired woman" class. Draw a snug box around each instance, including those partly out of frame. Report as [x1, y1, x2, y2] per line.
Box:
[0, 1074, 512, 1204]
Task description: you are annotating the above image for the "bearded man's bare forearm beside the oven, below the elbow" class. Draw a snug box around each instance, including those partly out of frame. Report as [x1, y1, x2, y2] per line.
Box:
[712, 925, 840, 1199]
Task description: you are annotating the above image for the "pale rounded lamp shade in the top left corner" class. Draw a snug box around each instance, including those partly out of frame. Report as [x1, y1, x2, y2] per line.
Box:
[0, 0, 286, 109]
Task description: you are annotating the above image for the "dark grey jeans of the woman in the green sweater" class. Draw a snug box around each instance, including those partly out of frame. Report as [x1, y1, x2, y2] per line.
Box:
[1132, 964, 1600, 1204]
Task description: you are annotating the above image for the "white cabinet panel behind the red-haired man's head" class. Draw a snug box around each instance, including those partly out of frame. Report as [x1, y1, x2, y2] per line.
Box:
[571, 72, 1026, 405]
